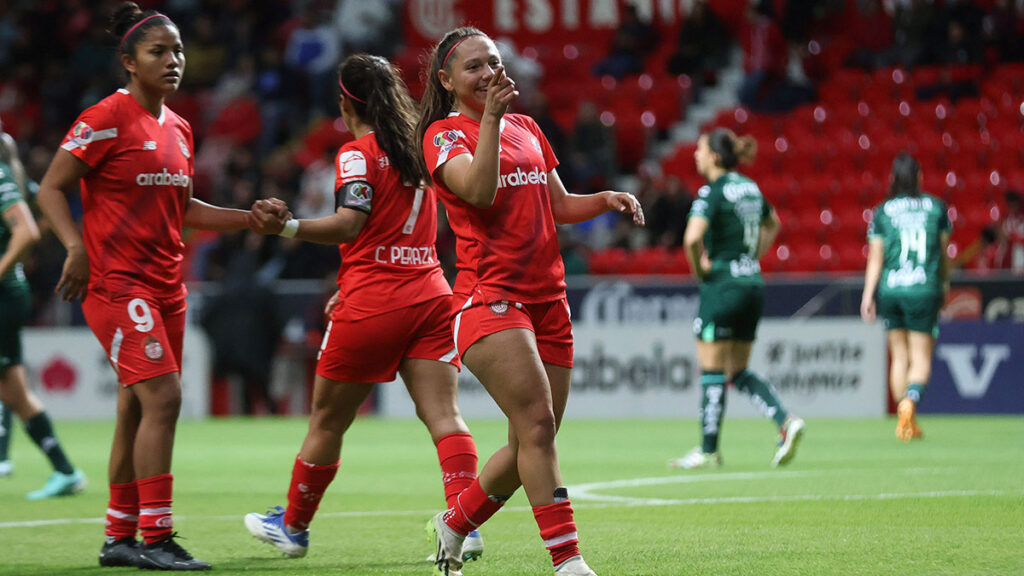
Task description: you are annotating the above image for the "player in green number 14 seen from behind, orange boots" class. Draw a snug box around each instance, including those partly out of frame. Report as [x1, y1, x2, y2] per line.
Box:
[860, 153, 951, 442]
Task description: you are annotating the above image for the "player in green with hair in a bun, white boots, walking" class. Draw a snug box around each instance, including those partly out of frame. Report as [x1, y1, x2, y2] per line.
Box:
[669, 128, 804, 468]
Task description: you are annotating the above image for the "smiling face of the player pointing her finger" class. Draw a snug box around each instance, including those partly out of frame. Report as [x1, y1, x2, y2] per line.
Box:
[438, 36, 502, 114]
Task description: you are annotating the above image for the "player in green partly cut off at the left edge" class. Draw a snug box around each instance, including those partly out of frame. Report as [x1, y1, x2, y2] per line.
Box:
[0, 125, 85, 494]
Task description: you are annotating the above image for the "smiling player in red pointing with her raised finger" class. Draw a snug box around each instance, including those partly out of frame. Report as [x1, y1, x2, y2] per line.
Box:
[418, 28, 643, 576]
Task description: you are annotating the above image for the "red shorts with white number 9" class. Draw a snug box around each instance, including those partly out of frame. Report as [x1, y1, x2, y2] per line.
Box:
[82, 292, 186, 386]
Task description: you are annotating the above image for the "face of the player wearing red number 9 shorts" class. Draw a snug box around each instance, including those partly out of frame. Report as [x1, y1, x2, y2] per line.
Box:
[121, 25, 185, 95]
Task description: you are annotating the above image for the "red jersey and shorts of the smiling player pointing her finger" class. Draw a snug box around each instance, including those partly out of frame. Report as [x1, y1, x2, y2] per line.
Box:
[423, 114, 572, 366]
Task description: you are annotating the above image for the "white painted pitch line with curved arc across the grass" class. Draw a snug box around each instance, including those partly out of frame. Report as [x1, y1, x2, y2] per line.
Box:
[0, 468, 1024, 529]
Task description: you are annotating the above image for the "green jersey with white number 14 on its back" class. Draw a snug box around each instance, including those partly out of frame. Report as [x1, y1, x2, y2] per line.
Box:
[867, 194, 952, 296]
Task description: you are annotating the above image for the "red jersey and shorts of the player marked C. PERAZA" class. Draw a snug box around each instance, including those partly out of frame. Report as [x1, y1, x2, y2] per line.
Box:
[316, 132, 459, 382]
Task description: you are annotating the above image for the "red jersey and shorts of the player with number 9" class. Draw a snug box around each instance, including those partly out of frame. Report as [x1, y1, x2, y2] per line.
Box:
[60, 89, 194, 385]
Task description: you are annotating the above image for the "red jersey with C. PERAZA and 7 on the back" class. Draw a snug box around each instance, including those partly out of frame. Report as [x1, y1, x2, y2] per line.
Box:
[335, 132, 452, 319]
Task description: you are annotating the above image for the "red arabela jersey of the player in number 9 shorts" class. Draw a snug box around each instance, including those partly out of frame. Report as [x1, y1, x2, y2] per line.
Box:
[60, 88, 193, 296]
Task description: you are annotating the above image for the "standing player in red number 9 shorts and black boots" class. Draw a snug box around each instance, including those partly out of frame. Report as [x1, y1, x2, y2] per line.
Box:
[39, 2, 285, 570]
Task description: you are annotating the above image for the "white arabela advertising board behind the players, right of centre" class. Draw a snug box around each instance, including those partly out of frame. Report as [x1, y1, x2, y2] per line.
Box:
[378, 319, 886, 418]
